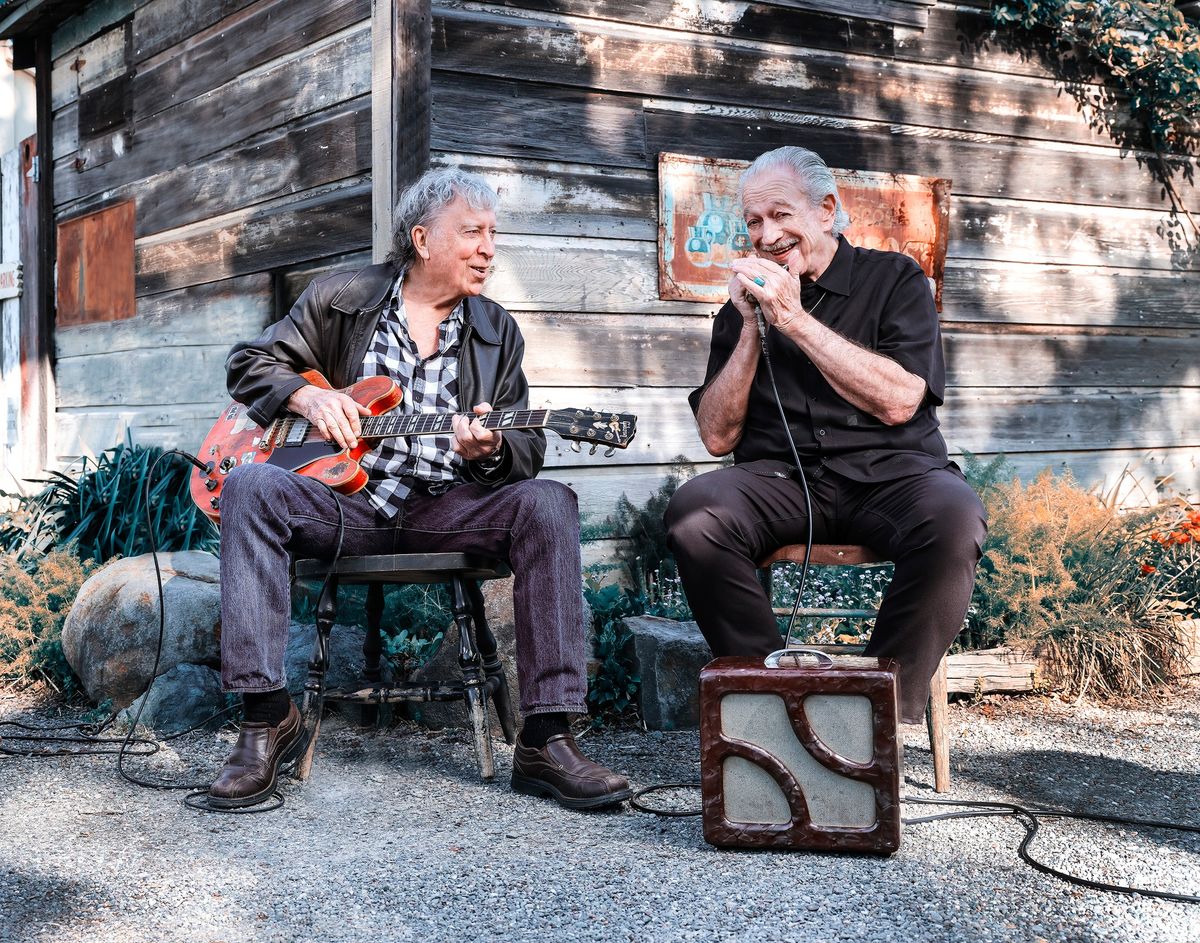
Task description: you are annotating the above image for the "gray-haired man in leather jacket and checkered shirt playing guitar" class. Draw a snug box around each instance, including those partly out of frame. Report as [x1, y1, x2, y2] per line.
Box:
[209, 169, 630, 809]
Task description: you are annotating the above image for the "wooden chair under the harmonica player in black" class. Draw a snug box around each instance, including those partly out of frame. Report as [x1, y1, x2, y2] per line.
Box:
[758, 543, 950, 792]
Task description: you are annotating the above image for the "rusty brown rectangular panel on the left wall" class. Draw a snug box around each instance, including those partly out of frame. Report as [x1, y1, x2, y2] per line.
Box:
[58, 200, 137, 328]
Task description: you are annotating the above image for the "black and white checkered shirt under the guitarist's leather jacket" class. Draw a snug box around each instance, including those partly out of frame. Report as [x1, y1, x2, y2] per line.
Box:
[359, 276, 463, 517]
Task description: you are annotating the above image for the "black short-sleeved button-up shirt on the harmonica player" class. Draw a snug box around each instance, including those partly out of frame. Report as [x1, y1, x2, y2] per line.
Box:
[688, 236, 949, 482]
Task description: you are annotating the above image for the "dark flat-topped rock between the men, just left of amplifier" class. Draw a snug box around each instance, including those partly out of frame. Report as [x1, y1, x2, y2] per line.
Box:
[625, 615, 713, 731]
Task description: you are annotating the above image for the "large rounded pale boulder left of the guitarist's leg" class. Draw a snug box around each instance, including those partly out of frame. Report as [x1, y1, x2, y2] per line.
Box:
[62, 551, 221, 707]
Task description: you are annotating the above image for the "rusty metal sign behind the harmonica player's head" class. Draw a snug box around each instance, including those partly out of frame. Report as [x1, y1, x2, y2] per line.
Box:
[659, 152, 950, 311]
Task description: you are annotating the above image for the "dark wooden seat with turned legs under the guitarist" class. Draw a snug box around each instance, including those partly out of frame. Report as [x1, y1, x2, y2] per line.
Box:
[294, 553, 516, 781]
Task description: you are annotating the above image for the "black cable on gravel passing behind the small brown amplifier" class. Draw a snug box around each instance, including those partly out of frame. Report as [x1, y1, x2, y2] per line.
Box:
[629, 782, 1200, 903]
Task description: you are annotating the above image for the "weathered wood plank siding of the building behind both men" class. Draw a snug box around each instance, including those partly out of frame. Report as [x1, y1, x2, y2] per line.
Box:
[54, 0, 1200, 516]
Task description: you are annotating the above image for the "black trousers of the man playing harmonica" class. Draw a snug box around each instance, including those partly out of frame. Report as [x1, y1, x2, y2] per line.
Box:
[666, 461, 988, 723]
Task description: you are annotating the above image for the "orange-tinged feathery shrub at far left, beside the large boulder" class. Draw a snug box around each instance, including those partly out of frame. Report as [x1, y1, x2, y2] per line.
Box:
[0, 551, 95, 693]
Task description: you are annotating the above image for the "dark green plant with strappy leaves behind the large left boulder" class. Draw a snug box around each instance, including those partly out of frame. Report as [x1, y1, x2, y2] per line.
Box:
[0, 444, 217, 563]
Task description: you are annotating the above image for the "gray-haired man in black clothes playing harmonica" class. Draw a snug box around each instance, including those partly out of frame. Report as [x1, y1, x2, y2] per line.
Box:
[666, 148, 986, 723]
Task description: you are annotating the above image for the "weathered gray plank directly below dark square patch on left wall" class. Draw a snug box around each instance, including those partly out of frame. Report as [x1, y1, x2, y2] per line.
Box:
[55, 19, 371, 203]
